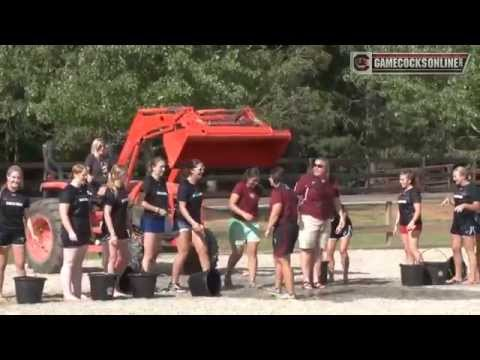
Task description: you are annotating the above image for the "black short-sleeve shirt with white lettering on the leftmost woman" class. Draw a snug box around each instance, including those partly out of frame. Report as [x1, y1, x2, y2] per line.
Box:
[0, 188, 30, 231]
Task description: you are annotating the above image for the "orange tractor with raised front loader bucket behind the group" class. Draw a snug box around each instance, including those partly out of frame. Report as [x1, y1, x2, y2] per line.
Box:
[26, 107, 291, 273]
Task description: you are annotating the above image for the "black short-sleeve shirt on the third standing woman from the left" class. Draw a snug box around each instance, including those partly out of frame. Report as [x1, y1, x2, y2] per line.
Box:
[102, 188, 128, 238]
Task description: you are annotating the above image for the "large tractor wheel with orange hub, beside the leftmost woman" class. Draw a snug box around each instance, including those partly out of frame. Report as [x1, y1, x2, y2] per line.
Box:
[25, 199, 63, 274]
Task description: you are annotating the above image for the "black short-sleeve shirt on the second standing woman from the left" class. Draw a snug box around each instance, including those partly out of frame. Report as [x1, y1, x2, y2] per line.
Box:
[59, 184, 91, 234]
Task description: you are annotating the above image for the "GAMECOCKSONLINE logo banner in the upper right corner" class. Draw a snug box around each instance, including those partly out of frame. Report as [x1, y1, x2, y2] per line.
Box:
[350, 52, 470, 75]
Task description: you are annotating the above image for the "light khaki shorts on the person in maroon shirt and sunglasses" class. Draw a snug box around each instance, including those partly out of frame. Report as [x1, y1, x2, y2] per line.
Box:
[298, 215, 331, 250]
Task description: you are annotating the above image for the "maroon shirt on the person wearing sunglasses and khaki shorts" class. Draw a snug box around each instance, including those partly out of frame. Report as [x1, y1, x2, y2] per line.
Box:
[295, 174, 340, 220]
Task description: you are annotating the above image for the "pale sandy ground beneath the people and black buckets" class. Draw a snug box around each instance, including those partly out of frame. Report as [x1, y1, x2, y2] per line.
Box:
[0, 249, 480, 315]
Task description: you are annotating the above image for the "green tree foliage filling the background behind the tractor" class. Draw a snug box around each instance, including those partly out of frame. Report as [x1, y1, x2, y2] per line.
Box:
[0, 45, 480, 161]
